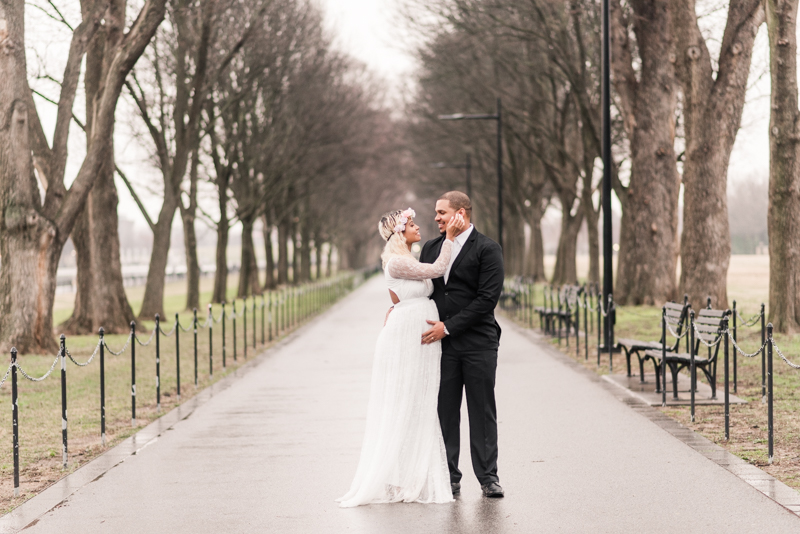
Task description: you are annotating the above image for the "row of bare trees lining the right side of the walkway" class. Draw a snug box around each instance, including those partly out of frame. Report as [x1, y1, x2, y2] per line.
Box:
[407, 0, 800, 331]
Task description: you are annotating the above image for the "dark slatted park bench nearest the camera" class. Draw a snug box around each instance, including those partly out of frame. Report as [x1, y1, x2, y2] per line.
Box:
[645, 308, 730, 399]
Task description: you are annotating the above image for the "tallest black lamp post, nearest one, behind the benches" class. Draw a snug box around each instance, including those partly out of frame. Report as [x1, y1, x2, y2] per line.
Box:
[601, 0, 614, 348]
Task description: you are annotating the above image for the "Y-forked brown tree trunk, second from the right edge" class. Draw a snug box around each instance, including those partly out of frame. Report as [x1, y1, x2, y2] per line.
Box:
[672, 0, 764, 309]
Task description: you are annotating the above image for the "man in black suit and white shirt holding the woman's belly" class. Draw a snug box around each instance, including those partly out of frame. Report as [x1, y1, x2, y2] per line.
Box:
[420, 191, 504, 497]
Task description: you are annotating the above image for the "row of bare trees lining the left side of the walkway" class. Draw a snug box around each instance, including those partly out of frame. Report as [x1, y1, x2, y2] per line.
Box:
[0, 0, 400, 353]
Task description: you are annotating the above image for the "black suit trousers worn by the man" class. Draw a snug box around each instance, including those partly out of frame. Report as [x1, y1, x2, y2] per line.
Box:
[439, 349, 499, 485]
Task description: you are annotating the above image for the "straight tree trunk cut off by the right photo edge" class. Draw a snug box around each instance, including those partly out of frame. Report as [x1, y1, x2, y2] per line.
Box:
[765, 0, 800, 333]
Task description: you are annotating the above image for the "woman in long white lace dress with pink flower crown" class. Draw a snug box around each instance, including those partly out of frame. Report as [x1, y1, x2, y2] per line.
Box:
[337, 208, 465, 507]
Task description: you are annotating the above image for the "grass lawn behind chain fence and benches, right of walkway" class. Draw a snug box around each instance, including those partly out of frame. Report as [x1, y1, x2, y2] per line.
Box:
[510, 256, 800, 489]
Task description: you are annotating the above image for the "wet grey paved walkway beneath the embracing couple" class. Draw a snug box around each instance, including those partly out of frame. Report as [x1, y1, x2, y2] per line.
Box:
[6, 277, 800, 534]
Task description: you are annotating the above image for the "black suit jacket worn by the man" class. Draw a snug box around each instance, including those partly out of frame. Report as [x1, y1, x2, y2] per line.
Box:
[420, 226, 505, 352]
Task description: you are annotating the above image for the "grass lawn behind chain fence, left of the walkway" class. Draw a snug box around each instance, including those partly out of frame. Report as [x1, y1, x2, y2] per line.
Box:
[0, 276, 354, 513]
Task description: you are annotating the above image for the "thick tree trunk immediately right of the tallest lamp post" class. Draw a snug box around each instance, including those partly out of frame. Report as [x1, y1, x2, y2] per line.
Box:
[612, 0, 680, 305]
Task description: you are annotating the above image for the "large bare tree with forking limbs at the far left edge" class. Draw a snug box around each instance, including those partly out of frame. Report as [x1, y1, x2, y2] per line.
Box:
[0, 0, 165, 352]
